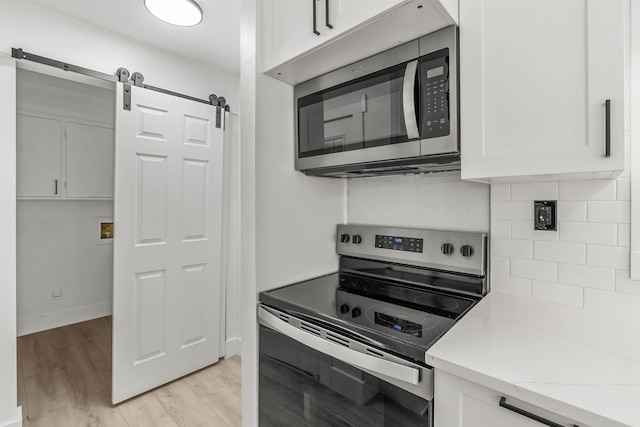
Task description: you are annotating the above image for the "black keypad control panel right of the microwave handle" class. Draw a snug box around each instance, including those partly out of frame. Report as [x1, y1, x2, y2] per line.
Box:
[419, 49, 451, 138]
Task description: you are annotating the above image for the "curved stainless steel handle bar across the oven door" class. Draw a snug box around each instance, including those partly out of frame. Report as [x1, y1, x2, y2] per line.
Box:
[258, 307, 420, 385]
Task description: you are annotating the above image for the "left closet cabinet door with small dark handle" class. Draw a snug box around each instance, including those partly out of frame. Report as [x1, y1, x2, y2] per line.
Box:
[16, 114, 62, 198]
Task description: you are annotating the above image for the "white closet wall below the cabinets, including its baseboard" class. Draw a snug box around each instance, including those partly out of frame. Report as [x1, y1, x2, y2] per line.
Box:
[16, 200, 113, 335]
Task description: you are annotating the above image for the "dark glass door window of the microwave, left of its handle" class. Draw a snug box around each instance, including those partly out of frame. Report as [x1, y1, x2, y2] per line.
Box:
[298, 64, 407, 157]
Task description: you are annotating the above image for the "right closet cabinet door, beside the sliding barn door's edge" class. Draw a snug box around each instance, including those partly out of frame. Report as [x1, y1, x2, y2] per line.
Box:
[66, 123, 114, 198]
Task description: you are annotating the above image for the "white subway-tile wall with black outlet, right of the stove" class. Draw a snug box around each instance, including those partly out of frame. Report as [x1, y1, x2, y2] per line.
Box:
[484, 1, 640, 317]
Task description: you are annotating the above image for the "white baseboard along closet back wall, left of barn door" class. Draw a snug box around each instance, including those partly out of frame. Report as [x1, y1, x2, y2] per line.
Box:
[17, 302, 113, 336]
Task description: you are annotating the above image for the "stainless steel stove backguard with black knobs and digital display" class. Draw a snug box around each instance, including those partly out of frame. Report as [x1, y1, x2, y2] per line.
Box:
[336, 224, 488, 276]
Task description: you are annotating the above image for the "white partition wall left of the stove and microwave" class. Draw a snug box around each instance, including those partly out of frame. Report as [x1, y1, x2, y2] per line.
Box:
[240, 0, 344, 426]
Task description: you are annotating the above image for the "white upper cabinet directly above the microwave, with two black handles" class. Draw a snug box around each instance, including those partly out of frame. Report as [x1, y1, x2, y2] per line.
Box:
[261, 0, 458, 84]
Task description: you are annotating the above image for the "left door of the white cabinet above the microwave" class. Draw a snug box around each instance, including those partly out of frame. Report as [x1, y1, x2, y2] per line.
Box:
[262, 0, 326, 70]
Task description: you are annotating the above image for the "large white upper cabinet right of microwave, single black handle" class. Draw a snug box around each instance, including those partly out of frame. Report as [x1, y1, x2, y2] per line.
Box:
[459, 0, 624, 182]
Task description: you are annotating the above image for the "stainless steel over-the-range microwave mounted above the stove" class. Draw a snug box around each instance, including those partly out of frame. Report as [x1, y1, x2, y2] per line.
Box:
[294, 26, 460, 178]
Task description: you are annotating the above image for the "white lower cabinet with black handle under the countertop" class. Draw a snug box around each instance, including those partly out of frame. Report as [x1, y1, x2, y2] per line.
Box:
[434, 369, 590, 427]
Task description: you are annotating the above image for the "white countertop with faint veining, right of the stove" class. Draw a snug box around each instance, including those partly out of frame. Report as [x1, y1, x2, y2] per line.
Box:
[426, 293, 640, 427]
